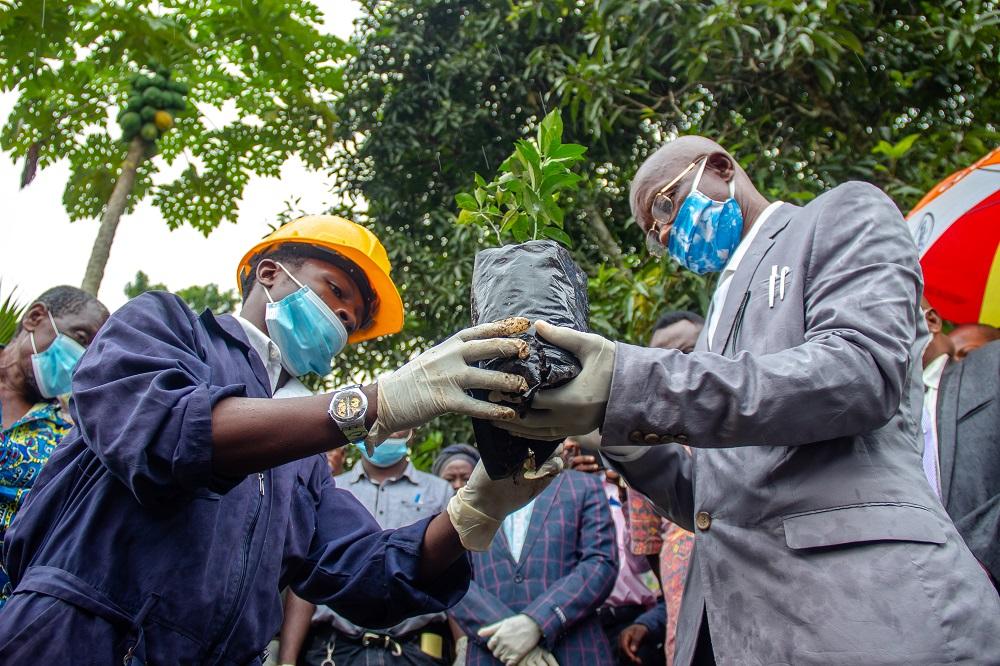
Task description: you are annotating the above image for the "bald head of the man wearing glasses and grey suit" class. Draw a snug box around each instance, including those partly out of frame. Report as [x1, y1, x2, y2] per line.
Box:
[629, 135, 767, 231]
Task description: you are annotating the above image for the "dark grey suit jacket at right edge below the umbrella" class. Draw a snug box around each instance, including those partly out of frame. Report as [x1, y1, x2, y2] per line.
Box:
[937, 342, 1000, 585]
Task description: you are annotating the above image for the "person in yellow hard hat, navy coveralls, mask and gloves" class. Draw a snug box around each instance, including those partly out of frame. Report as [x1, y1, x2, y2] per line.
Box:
[0, 216, 559, 666]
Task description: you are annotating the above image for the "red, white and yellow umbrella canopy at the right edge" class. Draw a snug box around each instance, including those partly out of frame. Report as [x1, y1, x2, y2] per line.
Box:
[906, 148, 1000, 326]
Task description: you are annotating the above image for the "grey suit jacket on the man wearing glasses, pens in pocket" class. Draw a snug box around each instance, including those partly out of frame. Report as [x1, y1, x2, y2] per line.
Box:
[602, 182, 1000, 666]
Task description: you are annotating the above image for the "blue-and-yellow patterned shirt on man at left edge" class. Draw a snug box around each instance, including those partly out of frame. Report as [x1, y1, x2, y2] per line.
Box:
[0, 402, 73, 607]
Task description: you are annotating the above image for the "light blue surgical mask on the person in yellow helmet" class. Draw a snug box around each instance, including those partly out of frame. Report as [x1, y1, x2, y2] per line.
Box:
[264, 264, 347, 377]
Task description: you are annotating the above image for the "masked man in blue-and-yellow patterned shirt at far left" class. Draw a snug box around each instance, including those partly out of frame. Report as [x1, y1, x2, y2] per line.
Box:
[0, 286, 108, 608]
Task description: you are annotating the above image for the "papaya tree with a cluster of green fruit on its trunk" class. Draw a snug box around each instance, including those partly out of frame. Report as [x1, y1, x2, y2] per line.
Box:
[0, 0, 347, 294]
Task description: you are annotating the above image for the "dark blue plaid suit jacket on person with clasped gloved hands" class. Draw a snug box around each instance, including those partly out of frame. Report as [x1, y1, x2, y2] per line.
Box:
[452, 471, 618, 666]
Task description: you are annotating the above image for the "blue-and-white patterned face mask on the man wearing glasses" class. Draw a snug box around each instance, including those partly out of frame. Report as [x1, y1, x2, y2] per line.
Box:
[667, 158, 743, 274]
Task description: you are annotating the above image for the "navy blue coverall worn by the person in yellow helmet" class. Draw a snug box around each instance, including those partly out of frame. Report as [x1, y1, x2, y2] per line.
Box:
[0, 293, 470, 664]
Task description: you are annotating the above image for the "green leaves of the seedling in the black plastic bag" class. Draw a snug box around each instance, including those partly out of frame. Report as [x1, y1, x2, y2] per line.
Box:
[455, 109, 587, 247]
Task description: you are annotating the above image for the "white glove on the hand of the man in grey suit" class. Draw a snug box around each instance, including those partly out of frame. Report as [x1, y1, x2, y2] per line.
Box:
[493, 321, 615, 440]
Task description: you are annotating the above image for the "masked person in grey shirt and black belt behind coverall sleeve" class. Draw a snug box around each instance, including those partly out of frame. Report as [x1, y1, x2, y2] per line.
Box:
[278, 430, 458, 666]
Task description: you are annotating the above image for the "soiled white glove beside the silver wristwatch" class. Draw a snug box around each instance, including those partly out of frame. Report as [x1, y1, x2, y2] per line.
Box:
[365, 317, 528, 446]
